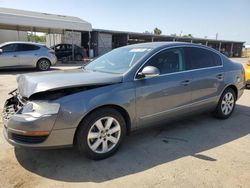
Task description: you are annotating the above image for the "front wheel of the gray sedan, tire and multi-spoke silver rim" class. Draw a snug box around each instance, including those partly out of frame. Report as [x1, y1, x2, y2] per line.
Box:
[76, 108, 126, 160]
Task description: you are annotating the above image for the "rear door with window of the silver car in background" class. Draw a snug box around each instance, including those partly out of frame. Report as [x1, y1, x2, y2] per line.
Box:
[16, 44, 40, 67]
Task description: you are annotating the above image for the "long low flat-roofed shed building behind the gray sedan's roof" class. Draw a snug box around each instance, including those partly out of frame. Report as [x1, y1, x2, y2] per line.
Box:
[91, 29, 244, 57]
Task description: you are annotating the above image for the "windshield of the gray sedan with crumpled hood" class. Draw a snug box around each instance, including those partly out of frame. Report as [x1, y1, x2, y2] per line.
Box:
[85, 48, 151, 74]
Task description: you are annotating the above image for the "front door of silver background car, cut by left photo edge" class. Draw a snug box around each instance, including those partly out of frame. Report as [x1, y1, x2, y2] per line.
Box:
[0, 44, 19, 67]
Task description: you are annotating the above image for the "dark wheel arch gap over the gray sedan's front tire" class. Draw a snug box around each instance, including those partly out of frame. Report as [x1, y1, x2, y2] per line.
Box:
[73, 104, 131, 145]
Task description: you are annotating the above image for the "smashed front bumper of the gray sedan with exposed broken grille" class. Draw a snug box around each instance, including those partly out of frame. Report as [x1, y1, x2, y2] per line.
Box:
[3, 91, 75, 148]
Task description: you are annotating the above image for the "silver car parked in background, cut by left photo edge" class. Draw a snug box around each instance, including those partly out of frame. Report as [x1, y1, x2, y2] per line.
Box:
[0, 42, 57, 71]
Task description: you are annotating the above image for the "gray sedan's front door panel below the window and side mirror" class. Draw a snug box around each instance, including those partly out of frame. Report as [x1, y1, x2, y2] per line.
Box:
[135, 73, 191, 127]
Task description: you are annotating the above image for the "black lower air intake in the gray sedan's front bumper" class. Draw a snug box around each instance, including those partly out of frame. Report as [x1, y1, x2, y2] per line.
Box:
[11, 133, 48, 144]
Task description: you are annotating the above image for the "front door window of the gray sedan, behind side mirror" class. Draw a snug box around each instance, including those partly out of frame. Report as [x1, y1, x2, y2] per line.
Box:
[144, 48, 185, 74]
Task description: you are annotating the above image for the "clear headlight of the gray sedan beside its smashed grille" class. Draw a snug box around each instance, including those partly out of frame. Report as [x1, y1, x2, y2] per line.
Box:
[21, 102, 60, 117]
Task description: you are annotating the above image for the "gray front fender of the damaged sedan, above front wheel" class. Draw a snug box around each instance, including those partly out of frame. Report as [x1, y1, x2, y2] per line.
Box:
[51, 82, 137, 129]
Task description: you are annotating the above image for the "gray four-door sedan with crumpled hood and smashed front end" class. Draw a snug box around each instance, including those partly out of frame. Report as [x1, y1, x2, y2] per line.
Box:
[3, 42, 245, 159]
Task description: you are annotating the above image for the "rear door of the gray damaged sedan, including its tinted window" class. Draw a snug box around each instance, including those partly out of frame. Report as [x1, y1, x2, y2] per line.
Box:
[184, 47, 224, 108]
